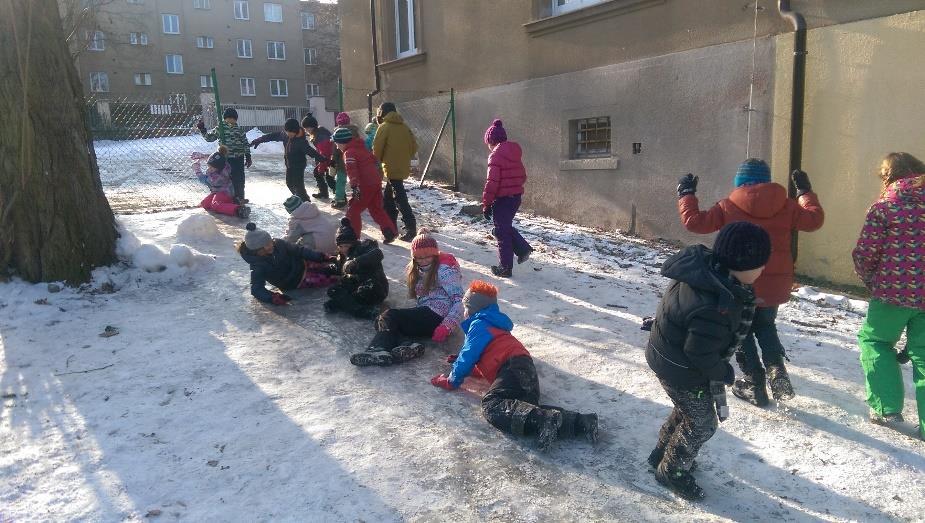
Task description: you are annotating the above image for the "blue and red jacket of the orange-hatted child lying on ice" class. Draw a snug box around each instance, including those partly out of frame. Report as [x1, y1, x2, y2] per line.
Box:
[448, 304, 530, 388]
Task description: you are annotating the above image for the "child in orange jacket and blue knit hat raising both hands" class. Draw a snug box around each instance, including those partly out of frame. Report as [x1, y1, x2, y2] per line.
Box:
[678, 158, 825, 407]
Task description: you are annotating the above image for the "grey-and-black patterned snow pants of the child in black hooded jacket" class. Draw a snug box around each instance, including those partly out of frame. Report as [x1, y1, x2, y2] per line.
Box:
[656, 380, 719, 470]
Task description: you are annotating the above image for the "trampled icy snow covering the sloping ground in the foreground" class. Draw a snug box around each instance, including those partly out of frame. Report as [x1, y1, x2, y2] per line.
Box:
[0, 162, 925, 521]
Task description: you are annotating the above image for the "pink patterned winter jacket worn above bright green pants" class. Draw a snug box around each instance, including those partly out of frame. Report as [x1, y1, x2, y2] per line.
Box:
[852, 174, 925, 310]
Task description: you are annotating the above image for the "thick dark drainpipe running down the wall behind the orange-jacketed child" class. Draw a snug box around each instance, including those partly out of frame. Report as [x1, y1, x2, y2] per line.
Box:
[777, 0, 806, 261]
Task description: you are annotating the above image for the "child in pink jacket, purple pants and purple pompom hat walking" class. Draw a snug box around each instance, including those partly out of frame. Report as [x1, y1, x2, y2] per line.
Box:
[482, 120, 533, 278]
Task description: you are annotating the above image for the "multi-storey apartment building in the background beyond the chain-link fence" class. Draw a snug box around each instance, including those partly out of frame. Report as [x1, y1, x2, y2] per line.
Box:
[73, 0, 339, 109]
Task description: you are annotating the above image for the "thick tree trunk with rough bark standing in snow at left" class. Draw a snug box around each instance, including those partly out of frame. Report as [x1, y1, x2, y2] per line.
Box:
[0, 0, 117, 284]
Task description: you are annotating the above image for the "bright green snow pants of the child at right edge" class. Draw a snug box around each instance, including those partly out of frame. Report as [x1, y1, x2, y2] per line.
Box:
[858, 299, 925, 434]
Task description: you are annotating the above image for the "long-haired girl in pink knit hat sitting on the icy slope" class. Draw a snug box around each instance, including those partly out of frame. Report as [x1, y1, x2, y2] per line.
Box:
[350, 228, 463, 367]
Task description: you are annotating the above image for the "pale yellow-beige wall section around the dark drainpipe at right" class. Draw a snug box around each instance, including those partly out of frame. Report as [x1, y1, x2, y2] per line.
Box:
[773, 11, 925, 285]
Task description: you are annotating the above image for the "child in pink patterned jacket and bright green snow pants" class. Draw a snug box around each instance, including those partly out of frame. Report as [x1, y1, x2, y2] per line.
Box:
[852, 153, 925, 439]
